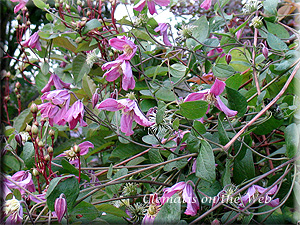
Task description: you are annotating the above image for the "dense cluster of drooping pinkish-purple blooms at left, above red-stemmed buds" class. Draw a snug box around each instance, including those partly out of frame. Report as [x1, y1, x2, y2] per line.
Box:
[38, 74, 87, 130]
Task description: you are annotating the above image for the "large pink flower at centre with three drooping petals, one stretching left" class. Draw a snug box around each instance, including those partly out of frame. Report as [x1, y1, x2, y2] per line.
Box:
[97, 98, 154, 136]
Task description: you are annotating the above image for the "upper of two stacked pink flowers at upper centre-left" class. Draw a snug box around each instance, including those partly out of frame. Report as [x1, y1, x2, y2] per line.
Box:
[109, 36, 137, 60]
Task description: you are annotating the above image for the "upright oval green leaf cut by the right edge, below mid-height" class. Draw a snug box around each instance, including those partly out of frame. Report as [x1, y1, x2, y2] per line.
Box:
[284, 123, 299, 158]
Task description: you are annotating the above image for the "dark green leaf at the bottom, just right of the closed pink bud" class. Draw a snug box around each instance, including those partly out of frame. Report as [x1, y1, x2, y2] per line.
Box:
[69, 201, 100, 224]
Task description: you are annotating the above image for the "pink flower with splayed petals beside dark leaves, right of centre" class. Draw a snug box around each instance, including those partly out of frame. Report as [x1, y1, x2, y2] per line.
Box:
[184, 79, 237, 116]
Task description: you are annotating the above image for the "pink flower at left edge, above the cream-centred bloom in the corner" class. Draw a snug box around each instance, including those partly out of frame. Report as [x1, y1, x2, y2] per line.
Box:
[5, 170, 36, 194]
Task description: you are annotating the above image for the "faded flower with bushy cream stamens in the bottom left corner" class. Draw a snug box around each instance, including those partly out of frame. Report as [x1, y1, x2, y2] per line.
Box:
[3, 197, 23, 224]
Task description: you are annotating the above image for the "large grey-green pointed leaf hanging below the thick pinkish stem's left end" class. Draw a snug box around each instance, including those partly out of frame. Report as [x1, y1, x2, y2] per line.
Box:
[196, 140, 216, 183]
